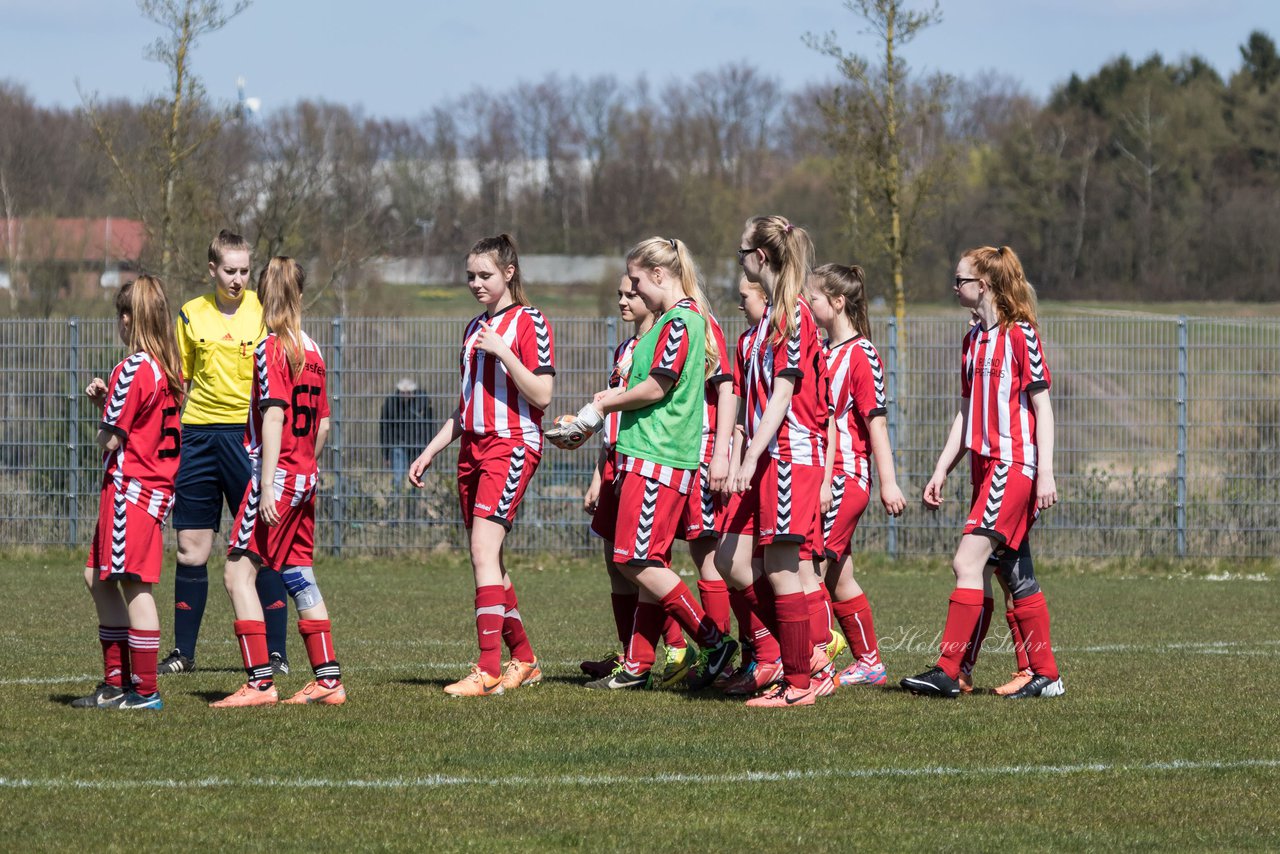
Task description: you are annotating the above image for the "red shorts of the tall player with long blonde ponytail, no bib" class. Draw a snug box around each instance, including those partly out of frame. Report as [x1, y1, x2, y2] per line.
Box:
[755, 457, 826, 561]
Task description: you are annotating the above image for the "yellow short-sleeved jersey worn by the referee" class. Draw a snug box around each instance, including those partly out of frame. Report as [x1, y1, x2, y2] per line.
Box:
[178, 291, 266, 424]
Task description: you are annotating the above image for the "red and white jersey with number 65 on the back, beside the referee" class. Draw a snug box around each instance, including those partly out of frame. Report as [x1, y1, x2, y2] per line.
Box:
[244, 332, 329, 481]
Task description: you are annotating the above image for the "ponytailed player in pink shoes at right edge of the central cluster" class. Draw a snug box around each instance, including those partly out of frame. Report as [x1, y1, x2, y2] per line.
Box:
[808, 264, 906, 685]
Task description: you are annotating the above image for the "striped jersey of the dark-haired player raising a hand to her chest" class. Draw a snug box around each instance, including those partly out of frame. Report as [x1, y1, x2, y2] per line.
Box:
[458, 305, 556, 452]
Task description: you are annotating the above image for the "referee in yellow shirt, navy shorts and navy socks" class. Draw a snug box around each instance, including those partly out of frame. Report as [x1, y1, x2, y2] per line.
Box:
[159, 229, 289, 673]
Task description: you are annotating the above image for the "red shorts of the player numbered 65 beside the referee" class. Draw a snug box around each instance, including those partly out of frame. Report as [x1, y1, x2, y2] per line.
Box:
[227, 469, 316, 572]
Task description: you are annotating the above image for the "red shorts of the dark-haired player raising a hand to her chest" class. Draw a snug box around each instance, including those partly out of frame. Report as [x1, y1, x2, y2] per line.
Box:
[458, 433, 543, 531]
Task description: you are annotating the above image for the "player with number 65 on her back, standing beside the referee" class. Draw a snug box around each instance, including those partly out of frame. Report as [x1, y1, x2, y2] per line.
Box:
[210, 257, 347, 708]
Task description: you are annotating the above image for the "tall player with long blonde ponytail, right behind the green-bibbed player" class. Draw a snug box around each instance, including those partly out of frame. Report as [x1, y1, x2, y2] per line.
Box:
[733, 216, 835, 707]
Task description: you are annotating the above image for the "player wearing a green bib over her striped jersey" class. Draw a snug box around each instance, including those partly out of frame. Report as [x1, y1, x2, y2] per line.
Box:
[580, 237, 737, 690]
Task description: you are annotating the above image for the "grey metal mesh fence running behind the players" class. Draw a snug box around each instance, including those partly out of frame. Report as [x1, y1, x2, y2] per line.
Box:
[0, 316, 1280, 557]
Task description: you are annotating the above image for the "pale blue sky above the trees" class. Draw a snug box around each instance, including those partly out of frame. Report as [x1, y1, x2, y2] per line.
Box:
[0, 0, 1280, 118]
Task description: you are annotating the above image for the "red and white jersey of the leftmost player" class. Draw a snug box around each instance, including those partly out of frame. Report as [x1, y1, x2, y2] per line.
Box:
[99, 351, 182, 521]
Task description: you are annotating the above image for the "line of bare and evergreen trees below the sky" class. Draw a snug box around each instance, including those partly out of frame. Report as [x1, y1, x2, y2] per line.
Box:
[0, 0, 1280, 314]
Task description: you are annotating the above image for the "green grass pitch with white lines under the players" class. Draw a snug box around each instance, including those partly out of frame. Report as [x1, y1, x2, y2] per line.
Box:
[0, 552, 1280, 851]
